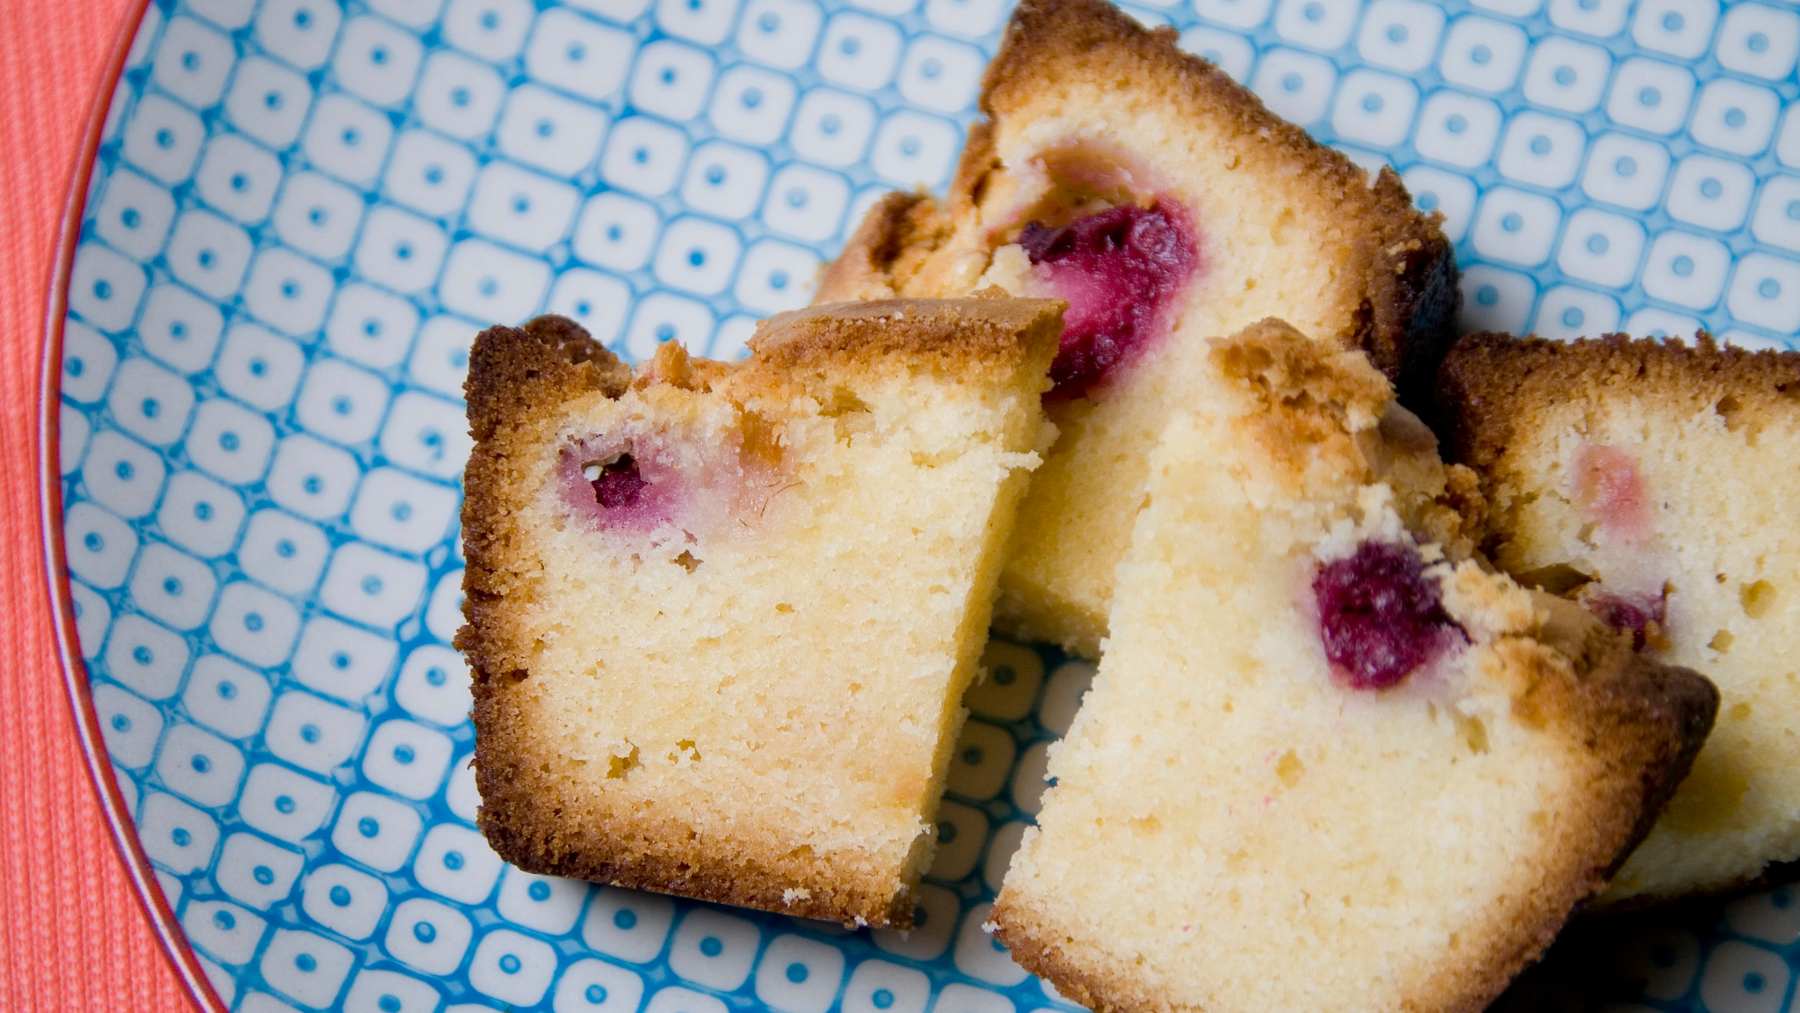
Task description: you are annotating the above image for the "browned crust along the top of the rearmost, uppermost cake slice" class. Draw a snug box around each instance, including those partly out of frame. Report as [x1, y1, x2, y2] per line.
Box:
[819, 0, 1460, 403]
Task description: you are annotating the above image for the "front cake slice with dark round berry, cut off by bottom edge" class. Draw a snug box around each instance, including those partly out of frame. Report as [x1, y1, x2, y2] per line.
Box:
[994, 322, 1717, 1013]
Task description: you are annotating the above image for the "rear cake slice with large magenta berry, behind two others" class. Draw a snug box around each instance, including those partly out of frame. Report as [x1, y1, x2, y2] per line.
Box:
[819, 0, 1456, 657]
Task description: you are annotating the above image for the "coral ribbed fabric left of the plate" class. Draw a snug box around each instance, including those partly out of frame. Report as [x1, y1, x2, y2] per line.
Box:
[0, 0, 189, 1009]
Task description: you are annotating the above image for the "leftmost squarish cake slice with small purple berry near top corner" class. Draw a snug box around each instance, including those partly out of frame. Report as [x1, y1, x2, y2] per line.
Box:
[457, 299, 1060, 927]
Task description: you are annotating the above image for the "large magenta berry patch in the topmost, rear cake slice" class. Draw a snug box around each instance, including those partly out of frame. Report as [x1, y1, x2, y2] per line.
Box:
[1019, 202, 1199, 399]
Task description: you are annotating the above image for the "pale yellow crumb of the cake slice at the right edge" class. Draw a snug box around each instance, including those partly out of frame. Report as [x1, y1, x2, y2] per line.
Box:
[1494, 385, 1800, 900]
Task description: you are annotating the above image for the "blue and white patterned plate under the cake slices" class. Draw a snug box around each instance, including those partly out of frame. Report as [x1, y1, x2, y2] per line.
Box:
[47, 0, 1800, 1013]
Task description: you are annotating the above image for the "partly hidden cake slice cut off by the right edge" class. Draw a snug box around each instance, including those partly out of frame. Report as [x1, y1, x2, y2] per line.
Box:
[1440, 335, 1800, 900]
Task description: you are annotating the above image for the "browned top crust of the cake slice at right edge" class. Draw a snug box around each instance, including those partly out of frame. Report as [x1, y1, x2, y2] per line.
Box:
[1436, 333, 1800, 471]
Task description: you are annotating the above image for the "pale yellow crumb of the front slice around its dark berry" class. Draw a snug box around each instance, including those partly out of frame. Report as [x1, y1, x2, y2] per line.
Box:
[997, 329, 1663, 1013]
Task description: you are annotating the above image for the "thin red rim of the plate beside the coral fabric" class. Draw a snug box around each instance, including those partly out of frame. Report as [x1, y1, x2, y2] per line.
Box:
[38, 0, 227, 1011]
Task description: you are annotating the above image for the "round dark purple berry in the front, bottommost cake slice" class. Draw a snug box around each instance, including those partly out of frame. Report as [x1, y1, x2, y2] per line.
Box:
[1312, 540, 1462, 689]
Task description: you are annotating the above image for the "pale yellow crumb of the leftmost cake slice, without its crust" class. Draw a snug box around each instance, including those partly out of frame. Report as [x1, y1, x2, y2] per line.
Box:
[511, 340, 1048, 921]
